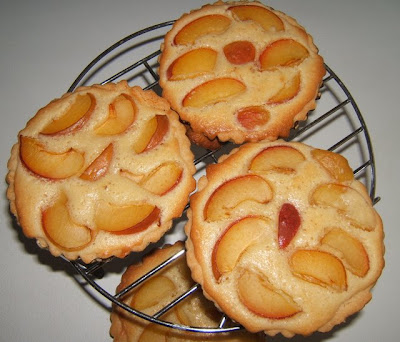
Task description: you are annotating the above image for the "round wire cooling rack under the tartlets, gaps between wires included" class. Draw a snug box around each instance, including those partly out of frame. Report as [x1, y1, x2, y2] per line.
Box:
[68, 21, 379, 333]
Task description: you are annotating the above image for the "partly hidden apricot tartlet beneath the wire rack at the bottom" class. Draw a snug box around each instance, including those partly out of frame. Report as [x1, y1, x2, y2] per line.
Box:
[110, 241, 262, 342]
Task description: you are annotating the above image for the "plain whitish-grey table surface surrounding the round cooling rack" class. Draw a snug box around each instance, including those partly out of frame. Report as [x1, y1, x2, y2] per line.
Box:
[0, 0, 400, 342]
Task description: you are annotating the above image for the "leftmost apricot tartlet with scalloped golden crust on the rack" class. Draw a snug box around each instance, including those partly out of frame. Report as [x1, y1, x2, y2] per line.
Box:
[7, 81, 195, 262]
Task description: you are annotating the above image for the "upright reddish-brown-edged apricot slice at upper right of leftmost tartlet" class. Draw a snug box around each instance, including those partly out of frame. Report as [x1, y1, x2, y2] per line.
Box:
[133, 114, 169, 154]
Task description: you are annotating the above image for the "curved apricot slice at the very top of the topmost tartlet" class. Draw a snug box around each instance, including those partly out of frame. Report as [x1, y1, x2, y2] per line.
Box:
[229, 5, 284, 31]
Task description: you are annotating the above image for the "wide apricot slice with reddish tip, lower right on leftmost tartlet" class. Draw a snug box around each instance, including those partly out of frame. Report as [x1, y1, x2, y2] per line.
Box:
[94, 201, 156, 232]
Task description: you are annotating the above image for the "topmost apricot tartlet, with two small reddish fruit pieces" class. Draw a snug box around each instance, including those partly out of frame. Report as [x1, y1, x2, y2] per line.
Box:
[159, 1, 325, 147]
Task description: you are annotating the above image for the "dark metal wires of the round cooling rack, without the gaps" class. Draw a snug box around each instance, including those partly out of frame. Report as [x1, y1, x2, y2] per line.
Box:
[68, 20, 379, 333]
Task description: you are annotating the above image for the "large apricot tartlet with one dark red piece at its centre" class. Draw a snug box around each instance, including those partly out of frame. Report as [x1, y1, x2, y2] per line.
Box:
[185, 140, 384, 337]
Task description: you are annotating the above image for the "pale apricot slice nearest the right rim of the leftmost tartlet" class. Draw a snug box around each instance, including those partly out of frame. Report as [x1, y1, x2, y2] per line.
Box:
[140, 162, 183, 196]
